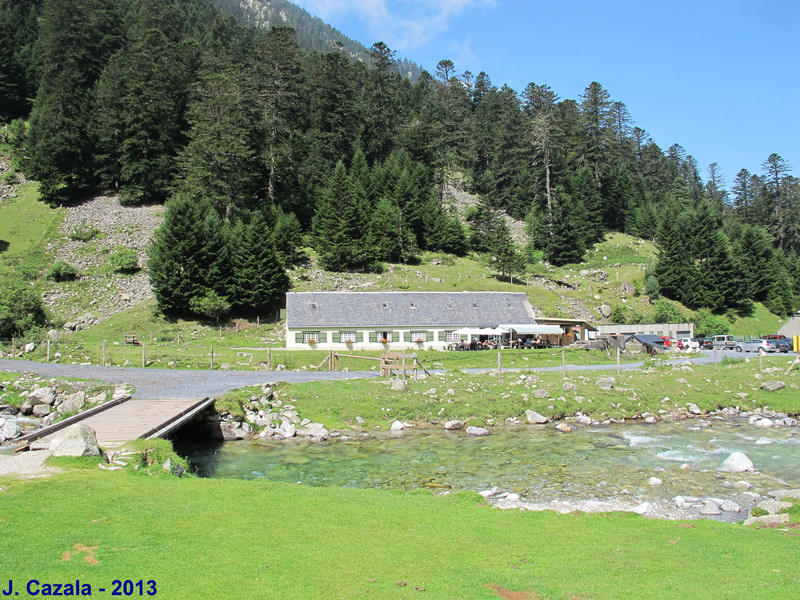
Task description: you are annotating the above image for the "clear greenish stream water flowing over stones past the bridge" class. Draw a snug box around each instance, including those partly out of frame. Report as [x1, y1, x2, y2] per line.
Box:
[178, 420, 800, 499]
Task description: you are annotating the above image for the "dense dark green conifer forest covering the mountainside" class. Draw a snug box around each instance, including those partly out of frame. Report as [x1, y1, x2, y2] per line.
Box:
[0, 0, 800, 328]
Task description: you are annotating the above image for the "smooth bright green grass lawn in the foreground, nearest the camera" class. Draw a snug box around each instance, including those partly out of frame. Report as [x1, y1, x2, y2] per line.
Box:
[0, 469, 800, 600]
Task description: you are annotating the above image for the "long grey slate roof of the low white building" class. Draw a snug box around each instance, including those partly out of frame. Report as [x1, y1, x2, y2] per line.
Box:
[286, 292, 536, 329]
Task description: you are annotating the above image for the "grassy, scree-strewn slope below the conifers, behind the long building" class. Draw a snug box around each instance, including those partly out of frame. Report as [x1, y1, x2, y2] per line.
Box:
[0, 157, 783, 350]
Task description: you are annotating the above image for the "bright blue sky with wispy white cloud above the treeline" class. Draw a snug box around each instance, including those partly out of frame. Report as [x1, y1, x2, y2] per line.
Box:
[295, 0, 800, 187]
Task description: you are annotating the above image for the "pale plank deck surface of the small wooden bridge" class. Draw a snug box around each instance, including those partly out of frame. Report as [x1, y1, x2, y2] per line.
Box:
[38, 398, 214, 446]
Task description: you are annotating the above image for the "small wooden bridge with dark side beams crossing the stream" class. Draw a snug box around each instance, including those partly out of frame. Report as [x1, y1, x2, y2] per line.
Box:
[15, 398, 214, 446]
